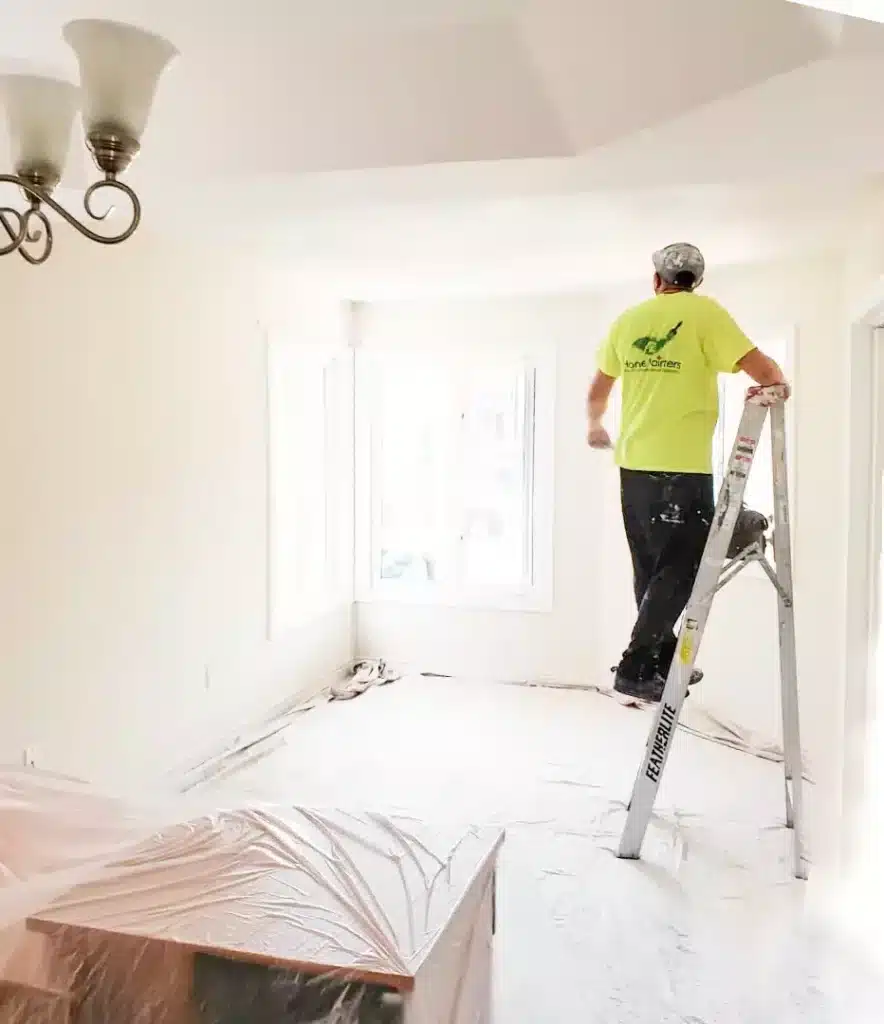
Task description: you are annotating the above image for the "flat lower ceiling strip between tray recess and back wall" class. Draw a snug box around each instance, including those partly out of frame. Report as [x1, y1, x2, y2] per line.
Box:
[157, 182, 853, 300]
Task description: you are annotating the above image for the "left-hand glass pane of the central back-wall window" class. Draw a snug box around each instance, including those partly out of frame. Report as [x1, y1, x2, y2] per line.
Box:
[373, 356, 453, 585]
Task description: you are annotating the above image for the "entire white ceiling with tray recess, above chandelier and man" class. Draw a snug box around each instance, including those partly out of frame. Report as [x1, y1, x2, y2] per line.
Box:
[0, 0, 884, 296]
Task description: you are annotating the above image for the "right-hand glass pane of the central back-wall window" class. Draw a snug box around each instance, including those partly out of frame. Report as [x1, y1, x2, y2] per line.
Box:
[460, 365, 534, 589]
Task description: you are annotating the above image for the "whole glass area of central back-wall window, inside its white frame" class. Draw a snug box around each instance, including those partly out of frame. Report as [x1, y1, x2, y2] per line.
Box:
[372, 353, 535, 595]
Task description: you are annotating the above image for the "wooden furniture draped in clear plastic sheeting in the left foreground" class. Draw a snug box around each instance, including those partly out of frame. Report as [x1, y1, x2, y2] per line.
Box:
[0, 769, 503, 1024]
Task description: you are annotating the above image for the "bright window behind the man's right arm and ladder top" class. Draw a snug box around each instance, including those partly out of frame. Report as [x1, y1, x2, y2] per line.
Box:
[713, 339, 795, 522]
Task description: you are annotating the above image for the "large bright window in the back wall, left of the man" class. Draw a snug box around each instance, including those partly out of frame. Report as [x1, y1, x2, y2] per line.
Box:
[357, 352, 554, 608]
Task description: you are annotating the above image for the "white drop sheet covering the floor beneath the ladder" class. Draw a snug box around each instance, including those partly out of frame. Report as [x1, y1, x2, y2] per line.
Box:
[215, 678, 884, 1024]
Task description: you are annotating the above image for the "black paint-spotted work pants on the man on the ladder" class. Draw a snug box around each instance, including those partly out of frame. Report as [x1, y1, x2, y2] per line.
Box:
[619, 469, 715, 679]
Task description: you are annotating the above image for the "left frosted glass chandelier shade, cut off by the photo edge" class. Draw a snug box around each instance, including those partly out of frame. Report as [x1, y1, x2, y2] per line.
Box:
[0, 75, 80, 177]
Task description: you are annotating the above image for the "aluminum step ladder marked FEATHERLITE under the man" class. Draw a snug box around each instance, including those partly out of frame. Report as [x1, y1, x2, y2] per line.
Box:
[618, 386, 808, 879]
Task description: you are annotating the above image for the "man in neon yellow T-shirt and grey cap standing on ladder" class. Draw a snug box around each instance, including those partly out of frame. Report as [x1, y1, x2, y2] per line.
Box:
[588, 243, 788, 701]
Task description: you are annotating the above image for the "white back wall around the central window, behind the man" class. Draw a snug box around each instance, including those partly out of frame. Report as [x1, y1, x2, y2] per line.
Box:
[357, 255, 847, 823]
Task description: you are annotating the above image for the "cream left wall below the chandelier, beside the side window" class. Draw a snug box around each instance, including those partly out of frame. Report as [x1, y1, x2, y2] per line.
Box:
[0, 229, 351, 780]
